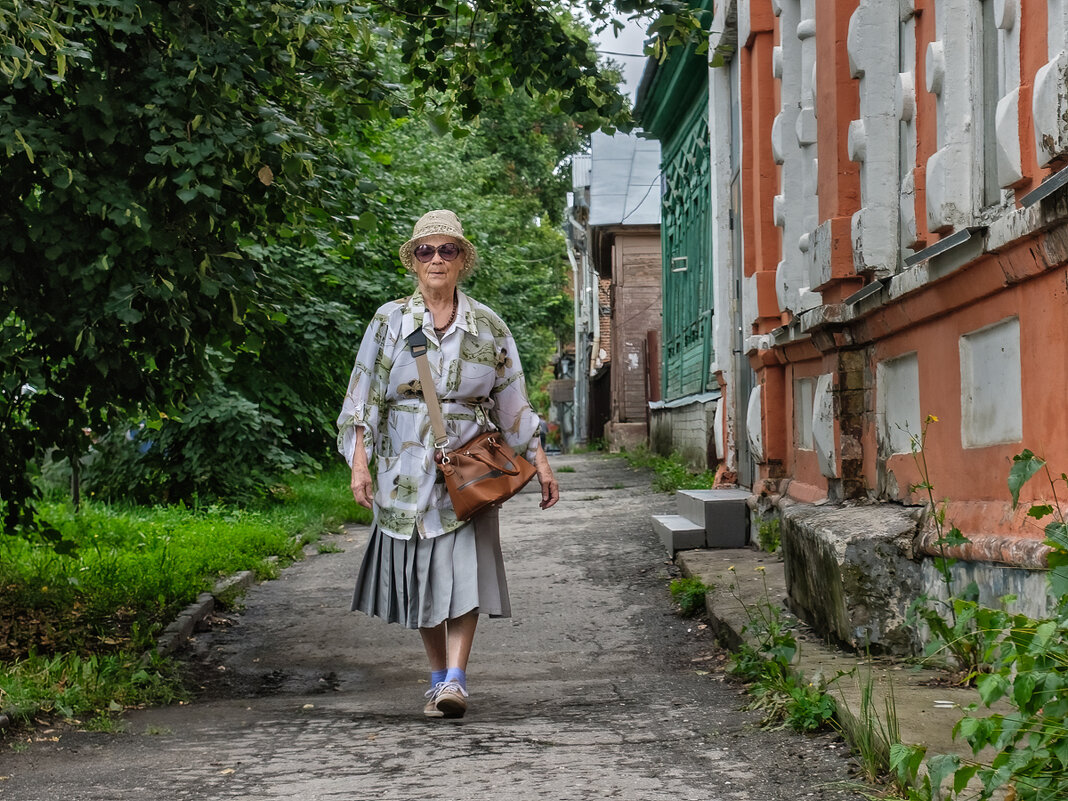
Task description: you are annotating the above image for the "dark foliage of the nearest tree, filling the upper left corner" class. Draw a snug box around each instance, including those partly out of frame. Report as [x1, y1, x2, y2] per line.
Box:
[0, 0, 383, 531]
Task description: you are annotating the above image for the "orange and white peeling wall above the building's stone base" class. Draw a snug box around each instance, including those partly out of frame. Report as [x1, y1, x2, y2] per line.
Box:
[726, 0, 1068, 559]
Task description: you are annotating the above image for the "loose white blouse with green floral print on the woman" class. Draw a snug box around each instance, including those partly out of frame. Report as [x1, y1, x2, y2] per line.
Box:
[337, 289, 539, 539]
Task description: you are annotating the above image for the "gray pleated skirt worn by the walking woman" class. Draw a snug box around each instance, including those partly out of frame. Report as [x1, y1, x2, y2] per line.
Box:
[352, 507, 512, 629]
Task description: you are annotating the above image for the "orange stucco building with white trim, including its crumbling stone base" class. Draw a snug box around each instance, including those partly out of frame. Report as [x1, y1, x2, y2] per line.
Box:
[639, 0, 1068, 649]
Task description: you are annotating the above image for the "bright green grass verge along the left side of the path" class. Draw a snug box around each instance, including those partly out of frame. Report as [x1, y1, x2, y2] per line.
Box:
[0, 466, 370, 725]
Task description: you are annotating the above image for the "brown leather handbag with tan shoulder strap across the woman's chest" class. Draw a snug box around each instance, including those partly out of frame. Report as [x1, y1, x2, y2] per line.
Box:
[408, 329, 535, 520]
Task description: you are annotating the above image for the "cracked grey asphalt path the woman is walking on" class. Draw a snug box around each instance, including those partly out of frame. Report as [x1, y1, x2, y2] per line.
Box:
[0, 454, 862, 801]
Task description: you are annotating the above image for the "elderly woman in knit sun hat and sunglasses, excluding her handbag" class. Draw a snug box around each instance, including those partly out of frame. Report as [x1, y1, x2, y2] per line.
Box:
[337, 210, 560, 718]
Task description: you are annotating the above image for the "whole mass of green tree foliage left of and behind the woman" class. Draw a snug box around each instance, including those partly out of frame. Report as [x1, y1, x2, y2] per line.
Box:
[0, 0, 709, 535]
